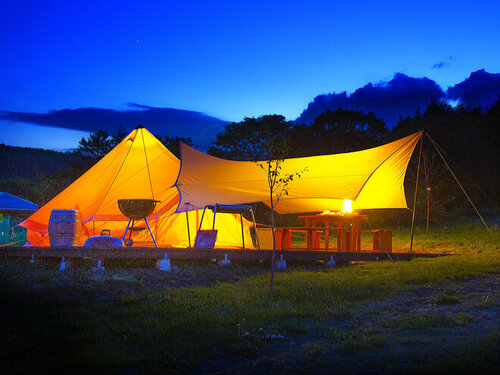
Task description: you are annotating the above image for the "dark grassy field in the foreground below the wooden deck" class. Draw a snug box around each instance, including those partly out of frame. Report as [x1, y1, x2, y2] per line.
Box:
[0, 226, 500, 374]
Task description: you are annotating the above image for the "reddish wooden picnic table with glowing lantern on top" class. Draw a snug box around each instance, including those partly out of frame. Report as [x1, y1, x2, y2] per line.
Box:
[299, 213, 368, 251]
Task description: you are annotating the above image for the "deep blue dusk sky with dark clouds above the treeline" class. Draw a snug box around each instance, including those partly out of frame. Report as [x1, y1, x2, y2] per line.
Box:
[0, 0, 500, 149]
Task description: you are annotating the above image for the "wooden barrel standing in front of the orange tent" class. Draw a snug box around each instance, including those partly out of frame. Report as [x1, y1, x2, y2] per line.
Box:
[49, 210, 81, 247]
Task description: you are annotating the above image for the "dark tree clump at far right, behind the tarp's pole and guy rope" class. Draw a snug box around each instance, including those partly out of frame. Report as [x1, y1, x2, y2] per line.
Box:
[390, 98, 500, 217]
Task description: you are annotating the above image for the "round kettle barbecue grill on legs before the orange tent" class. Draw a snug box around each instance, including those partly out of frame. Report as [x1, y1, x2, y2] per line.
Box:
[118, 199, 160, 247]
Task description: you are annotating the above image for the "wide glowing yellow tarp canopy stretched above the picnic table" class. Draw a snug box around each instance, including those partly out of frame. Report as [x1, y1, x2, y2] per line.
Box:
[176, 132, 422, 213]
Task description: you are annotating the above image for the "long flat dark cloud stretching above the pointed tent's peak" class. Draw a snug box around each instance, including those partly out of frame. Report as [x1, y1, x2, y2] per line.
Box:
[0, 103, 228, 148]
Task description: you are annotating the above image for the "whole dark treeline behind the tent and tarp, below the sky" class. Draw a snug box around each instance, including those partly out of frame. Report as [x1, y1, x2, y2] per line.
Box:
[0, 98, 500, 224]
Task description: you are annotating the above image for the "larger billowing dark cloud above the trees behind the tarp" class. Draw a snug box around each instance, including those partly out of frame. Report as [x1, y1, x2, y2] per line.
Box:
[296, 73, 445, 126]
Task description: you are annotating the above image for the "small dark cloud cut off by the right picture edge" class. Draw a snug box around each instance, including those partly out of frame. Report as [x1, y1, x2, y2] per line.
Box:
[448, 69, 500, 106]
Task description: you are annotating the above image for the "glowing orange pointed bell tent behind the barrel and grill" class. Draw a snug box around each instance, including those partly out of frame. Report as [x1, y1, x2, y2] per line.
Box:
[20, 127, 252, 248]
